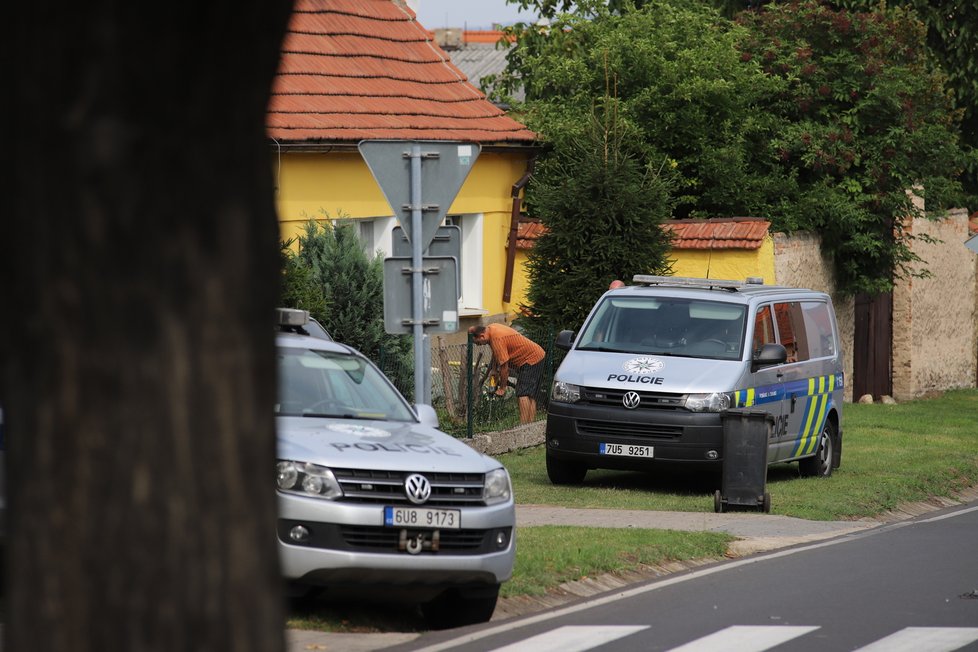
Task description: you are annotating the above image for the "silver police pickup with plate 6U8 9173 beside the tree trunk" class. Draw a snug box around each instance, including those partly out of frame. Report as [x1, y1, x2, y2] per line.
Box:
[275, 309, 516, 628]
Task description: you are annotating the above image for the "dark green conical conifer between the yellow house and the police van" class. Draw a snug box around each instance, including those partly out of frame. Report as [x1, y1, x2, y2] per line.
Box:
[521, 105, 669, 341]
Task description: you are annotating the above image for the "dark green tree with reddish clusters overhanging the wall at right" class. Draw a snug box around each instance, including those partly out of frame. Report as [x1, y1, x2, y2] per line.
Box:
[739, 0, 963, 294]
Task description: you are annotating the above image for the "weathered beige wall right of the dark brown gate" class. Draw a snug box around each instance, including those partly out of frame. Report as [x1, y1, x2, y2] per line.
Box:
[893, 209, 978, 400]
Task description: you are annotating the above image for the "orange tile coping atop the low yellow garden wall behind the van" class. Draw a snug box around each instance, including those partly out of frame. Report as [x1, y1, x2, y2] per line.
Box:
[516, 217, 771, 249]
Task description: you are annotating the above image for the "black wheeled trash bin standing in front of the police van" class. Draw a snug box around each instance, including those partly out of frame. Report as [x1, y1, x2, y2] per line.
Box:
[713, 408, 774, 513]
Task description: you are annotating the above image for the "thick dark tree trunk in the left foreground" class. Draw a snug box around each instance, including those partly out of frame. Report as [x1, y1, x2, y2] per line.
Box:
[0, 0, 291, 652]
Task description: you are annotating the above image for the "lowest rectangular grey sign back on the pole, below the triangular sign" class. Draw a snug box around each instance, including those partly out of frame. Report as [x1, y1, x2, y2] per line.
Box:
[384, 256, 458, 335]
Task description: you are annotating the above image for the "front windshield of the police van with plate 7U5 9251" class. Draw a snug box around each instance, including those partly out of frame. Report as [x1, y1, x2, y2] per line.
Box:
[577, 296, 747, 360]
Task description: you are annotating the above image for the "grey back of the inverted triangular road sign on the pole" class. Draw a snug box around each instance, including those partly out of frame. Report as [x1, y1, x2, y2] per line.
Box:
[358, 140, 482, 249]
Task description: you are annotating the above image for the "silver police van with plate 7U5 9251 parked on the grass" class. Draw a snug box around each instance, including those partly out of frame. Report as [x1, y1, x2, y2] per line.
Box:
[546, 275, 844, 484]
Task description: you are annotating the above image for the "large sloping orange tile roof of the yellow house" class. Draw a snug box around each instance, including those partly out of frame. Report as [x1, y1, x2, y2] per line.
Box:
[266, 0, 536, 145]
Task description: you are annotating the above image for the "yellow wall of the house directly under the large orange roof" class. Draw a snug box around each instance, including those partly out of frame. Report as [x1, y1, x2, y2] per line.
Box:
[272, 152, 527, 316]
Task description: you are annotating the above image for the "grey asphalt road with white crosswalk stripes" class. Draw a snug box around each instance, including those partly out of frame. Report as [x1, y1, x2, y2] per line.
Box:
[392, 501, 978, 652]
